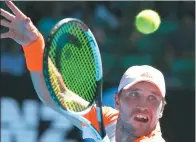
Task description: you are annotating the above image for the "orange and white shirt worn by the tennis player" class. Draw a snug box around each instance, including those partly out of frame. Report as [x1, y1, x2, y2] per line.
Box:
[83, 106, 165, 142]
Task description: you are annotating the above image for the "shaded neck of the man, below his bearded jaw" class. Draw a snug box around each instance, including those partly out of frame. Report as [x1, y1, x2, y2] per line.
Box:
[115, 118, 137, 142]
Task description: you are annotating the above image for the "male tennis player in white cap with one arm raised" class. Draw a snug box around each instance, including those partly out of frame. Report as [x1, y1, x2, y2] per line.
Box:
[1, 1, 166, 142]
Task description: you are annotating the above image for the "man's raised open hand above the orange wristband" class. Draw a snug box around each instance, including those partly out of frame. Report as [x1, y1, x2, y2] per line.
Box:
[0, 1, 38, 46]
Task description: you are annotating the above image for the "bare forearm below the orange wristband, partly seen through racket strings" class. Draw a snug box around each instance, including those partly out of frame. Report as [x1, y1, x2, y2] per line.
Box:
[30, 56, 89, 110]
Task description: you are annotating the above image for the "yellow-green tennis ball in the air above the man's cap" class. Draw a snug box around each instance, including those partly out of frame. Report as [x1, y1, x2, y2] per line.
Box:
[135, 9, 161, 34]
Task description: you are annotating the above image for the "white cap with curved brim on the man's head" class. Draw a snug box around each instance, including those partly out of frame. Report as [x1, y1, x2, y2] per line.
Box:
[118, 65, 166, 97]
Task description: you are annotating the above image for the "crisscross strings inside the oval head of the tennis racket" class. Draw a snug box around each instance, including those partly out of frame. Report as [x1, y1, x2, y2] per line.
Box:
[49, 24, 97, 112]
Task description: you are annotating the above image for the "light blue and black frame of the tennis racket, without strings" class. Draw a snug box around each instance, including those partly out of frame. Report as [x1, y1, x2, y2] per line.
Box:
[43, 18, 110, 142]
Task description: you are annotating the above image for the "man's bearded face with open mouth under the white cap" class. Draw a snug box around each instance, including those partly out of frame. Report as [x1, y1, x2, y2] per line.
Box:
[115, 82, 163, 137]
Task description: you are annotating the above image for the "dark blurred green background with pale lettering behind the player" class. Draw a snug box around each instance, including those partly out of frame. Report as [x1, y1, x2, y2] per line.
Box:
[0, 1, 195, 142]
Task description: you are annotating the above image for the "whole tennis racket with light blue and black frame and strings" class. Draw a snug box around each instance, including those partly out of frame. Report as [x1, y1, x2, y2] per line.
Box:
[43, 18, 109, 142]
